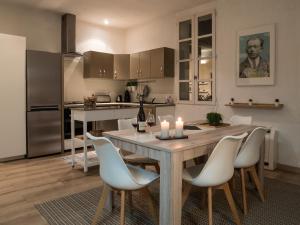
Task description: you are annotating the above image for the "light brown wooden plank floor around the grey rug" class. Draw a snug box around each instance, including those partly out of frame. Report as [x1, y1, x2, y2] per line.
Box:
[0, 153, 300, 225]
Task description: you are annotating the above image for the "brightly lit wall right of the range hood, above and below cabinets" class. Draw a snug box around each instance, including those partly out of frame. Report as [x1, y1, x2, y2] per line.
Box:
[64, 21, 125, 101]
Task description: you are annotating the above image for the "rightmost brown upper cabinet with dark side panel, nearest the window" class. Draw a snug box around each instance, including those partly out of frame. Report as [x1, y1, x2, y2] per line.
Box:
[150, 48, 174, 78]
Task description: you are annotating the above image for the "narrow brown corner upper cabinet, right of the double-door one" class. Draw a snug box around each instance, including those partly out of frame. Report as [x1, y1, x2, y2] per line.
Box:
[114, 54, 130, 80]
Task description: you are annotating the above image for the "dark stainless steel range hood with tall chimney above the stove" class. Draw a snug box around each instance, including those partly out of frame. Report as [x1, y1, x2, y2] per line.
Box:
[61, 13, 82, 58]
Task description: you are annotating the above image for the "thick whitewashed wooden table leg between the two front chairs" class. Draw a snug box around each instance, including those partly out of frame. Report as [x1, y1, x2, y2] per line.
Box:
[159, 152, 183, 225]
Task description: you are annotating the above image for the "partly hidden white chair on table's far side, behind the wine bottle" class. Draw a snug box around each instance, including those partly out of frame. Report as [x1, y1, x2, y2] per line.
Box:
[118, 118, 160, 173]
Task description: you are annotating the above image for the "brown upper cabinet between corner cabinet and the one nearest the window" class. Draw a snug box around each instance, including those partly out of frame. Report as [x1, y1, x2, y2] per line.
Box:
[130, 51, 150, 79]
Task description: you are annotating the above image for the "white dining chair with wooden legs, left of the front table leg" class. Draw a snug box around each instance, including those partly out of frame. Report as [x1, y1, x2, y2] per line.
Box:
[86, 133, 159, 225]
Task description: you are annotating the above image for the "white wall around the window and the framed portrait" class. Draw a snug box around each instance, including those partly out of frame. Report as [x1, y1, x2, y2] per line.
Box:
[126, 0, 300, 167]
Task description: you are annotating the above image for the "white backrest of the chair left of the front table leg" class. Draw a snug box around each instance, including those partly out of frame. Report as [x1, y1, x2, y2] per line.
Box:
[86, 133, 139, 190]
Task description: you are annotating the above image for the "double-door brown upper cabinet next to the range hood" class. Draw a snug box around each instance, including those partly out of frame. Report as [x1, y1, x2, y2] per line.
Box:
[84, 51, 114, 79]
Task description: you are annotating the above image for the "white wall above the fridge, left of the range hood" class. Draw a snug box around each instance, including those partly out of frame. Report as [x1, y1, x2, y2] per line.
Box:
[0, 3, 61, 52]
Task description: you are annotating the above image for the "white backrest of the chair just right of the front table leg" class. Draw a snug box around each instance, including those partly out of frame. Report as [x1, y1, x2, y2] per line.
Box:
[193, 133, 248, 187]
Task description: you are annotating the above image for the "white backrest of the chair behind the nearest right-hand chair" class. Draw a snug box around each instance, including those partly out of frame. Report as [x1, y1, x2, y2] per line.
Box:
[234, 127, 267, 167]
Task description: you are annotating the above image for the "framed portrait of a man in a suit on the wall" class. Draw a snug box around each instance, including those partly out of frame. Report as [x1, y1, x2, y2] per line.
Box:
[236, 24, 275, 86]
